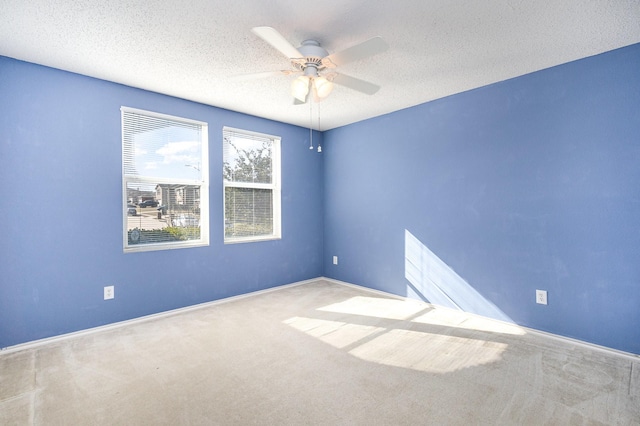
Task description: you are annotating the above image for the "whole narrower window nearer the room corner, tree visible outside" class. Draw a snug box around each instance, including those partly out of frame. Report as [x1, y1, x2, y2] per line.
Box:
[222, 127, 281, 243]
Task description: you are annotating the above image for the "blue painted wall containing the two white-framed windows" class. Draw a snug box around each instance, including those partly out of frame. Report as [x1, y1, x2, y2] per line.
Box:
[0, 57, 323, 348]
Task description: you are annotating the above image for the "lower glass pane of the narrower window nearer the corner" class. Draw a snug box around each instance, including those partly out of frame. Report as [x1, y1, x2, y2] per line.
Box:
[224, 187, 273, 237]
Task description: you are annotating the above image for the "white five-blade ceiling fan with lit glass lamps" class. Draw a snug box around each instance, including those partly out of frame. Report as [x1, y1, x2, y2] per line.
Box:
[241, 27, 389, 104]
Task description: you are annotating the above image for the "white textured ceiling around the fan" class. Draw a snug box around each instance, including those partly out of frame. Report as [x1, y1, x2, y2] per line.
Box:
[0, 0, 640, 130]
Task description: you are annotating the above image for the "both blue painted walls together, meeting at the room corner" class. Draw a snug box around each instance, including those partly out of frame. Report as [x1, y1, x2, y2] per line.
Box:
[0, 45, 640, 354]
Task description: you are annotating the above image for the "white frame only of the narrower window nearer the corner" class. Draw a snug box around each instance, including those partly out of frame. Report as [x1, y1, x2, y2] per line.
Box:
[222, 126, 282, 244]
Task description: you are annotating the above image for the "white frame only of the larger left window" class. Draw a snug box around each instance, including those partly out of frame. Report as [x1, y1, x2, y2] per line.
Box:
[120, 106, 210, 253]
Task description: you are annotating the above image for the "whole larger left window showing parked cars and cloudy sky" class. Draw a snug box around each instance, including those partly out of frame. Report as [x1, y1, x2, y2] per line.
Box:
[121, 107, 209, 252]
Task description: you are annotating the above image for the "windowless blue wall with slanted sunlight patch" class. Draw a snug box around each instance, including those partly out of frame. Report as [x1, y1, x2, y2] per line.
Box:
[324, 45, 640, 354]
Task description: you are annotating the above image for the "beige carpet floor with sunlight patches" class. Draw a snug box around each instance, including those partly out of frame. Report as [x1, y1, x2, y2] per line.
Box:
[0, 280, 640, 425]
